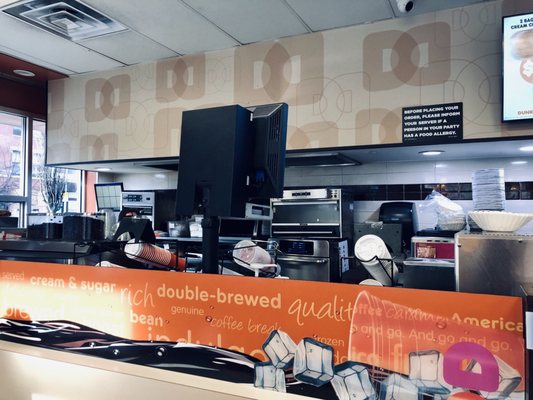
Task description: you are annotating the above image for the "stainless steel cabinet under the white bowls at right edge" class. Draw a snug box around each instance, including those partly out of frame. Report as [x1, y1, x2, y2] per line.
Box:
[455, 232, 533, 296]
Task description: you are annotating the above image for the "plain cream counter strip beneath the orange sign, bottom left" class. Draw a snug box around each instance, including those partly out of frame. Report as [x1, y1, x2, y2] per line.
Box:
[0, 340, 296, 400]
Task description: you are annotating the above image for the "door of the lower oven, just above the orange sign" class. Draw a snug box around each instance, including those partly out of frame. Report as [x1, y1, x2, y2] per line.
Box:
[276, 256, 330, 282]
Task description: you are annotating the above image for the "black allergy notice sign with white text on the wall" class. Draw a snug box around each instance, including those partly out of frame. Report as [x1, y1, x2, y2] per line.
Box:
[402, 103, 463, 144]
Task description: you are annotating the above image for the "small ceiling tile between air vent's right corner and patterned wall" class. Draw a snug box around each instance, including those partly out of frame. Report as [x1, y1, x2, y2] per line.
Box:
[79, 31, 178, 65]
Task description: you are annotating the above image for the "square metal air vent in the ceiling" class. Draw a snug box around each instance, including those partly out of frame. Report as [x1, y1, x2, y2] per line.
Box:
[1, 0, 127, 41]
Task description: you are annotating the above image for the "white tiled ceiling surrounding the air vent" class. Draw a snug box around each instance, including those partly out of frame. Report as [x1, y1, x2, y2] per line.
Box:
[0, 0, 491, 75]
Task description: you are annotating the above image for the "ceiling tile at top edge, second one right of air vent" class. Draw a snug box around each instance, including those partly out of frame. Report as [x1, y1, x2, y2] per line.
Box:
[184, 0, 309, 43]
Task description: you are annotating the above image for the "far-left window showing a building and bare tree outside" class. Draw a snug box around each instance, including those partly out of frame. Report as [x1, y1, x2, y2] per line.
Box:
[0, 110, 83, 230]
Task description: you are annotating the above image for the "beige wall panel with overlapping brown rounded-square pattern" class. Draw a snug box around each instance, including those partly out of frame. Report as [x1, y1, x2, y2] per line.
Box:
[47, 0, 533, 164]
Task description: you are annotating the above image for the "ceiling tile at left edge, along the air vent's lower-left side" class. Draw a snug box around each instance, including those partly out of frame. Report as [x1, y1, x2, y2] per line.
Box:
[0, 13, 122, 74]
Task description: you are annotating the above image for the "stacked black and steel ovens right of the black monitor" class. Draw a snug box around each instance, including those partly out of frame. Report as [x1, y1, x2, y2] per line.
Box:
[270, 188, 354, 282]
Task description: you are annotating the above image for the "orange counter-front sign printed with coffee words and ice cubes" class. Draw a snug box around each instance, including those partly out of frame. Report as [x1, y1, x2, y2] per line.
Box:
[0, 261, 525, 400]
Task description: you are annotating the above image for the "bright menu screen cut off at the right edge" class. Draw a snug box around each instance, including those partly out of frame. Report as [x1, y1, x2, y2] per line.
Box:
[502, 13, 533, 121]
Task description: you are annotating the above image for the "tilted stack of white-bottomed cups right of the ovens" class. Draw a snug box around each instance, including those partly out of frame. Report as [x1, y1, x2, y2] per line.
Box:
[354, 235, 398, 286]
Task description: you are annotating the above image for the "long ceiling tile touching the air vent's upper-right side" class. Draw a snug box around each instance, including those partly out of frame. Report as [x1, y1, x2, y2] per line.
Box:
[85, 0, 238, 54]
